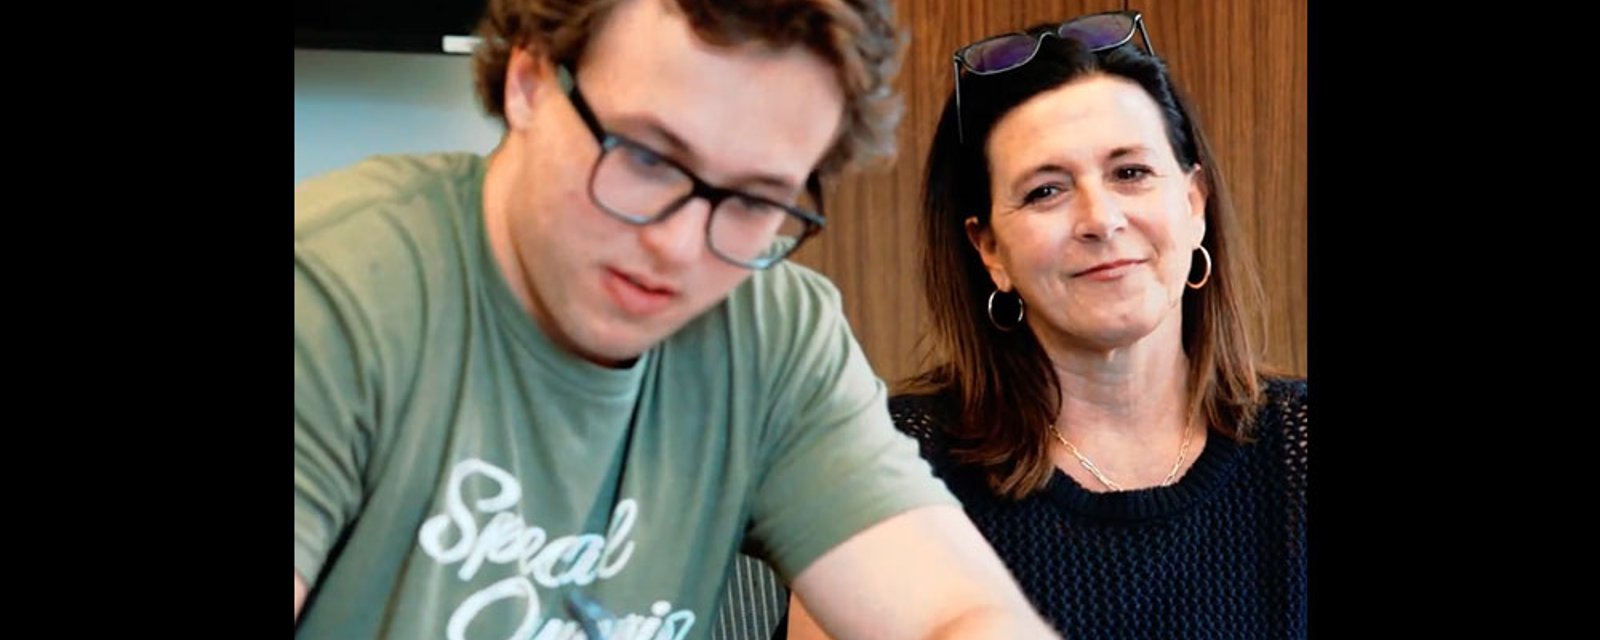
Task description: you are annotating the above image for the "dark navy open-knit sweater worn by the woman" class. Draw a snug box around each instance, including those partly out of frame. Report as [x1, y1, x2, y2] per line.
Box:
[890, 379, 1307, 640]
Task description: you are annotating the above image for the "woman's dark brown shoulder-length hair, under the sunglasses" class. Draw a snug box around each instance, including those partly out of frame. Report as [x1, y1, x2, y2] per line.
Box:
[901, 26, 1262, 499]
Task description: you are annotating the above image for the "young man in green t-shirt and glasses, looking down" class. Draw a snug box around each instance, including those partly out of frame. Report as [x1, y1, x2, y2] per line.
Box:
[294, 0, 1051, 640]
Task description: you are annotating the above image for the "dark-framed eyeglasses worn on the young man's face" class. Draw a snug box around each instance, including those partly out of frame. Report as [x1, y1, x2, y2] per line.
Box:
[555, 64, 827, 269]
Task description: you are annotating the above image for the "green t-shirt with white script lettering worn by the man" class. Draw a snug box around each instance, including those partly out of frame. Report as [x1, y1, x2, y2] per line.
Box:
[294, 154, 957, 640]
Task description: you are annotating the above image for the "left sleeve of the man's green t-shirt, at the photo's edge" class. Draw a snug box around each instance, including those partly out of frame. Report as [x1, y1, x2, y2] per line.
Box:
[294, 246, 374, 584]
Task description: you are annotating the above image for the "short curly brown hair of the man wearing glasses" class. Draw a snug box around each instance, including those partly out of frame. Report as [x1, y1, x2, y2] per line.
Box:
[474, 0, 906, 176]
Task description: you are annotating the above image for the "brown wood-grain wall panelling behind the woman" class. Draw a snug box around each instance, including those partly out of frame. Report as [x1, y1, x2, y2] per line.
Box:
[794, 0, 1307, 382]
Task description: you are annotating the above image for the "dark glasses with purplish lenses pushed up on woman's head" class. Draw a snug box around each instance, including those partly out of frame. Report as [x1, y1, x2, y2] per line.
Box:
[952, 5, 1155, 142]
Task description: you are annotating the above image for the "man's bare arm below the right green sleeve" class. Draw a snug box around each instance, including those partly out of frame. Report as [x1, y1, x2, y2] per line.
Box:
[789, 506, 1059, 640]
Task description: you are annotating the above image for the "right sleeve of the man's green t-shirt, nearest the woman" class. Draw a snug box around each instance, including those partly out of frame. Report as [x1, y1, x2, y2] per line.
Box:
[750, 274, 958, 579]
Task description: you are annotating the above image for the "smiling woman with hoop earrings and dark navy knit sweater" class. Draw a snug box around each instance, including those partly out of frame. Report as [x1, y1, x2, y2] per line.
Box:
[790, 13, 1307, 638]
